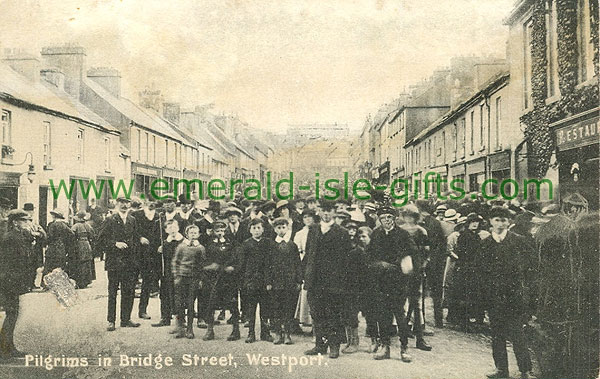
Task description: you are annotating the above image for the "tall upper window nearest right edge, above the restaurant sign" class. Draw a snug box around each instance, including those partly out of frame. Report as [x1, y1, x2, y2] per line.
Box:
[577, 0, 594, 83]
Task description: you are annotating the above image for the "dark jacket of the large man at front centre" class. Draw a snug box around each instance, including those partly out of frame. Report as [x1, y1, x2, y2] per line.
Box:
[304, 224, 352, 294]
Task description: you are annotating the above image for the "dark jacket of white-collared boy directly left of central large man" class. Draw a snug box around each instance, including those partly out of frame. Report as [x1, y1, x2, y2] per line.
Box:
[269, 241, 303, 290]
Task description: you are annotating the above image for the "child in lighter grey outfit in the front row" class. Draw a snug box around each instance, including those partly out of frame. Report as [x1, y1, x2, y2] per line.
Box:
[171, 225, 205, 339]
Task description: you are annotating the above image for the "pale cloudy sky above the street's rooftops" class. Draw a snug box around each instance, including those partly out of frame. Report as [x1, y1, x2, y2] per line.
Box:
[0, 0, 515, 132]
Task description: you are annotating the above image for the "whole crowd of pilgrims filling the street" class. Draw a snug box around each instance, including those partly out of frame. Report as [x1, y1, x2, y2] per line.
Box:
[0, 194, 599, 378]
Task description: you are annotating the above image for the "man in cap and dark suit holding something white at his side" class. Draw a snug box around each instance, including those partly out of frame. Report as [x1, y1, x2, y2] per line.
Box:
[367, 206, 417, 362]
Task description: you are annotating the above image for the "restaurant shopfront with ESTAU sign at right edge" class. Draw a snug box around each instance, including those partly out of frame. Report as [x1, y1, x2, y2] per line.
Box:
[554, 111, 600, 210]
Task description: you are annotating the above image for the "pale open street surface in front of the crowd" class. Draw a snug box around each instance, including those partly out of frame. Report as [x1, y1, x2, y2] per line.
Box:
[0, 262, 518, 379]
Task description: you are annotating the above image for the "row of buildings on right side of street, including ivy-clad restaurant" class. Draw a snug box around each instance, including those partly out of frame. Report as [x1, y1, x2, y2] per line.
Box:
[352, 0, 600, 209]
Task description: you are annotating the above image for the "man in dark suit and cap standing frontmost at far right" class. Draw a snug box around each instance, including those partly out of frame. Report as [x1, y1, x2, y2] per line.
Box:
[482, 206, 535, 379]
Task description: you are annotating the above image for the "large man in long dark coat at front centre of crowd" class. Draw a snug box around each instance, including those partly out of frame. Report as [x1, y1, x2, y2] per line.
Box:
[304, 201, 352, 359]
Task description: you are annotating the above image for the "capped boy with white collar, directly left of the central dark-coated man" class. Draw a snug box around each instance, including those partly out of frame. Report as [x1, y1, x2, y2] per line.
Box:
[269, 217, 303, 345]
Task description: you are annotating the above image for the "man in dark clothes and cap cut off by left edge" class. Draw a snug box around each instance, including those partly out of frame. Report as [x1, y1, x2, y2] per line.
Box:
[0, 209, 33, 359]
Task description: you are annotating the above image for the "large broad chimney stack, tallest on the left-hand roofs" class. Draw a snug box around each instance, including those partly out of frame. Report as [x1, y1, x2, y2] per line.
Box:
[42, 44, 85, 98]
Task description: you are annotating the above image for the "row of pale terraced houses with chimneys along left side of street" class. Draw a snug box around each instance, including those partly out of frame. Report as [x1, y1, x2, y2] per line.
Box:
[0, 45, 276, 229]
